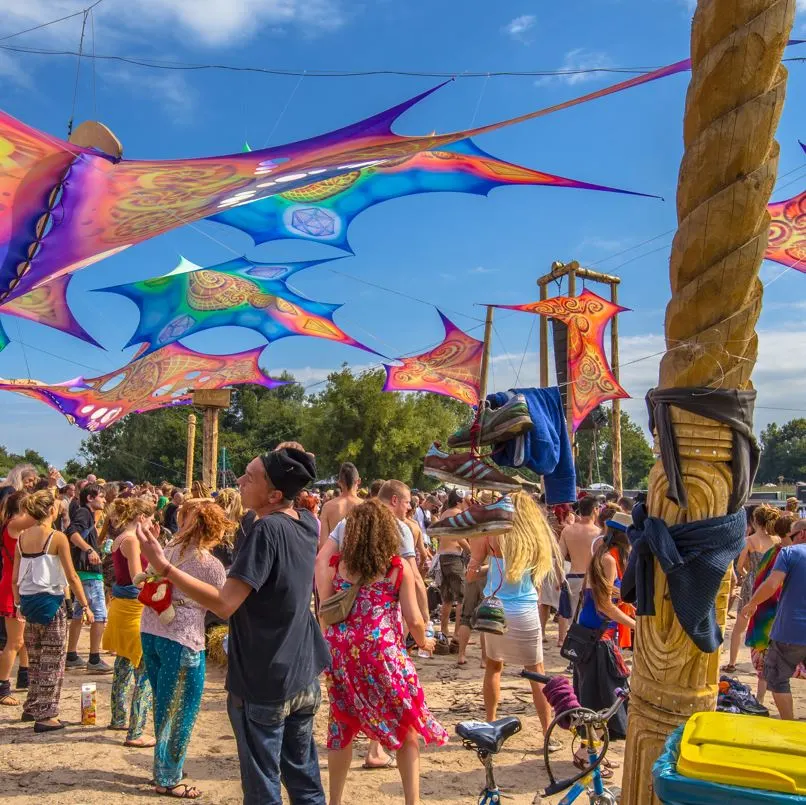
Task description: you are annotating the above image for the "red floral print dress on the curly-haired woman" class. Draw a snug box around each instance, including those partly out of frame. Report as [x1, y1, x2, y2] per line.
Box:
[325, 555, 448, 751]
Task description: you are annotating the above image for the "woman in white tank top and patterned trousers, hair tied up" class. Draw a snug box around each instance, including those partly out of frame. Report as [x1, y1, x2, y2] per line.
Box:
[12, 489, 93, 732]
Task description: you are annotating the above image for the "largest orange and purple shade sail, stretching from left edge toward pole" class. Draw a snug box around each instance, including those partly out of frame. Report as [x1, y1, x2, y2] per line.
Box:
[0, 61, 688, 304]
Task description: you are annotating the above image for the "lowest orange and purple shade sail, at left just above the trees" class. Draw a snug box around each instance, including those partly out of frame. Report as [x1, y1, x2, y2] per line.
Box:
[0, 344, 285, 431]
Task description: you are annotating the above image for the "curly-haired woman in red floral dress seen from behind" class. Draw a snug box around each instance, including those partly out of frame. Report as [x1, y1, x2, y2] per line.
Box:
[319, 499, 448, 805]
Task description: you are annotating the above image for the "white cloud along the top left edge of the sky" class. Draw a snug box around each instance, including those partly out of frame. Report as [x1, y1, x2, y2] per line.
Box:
[0, 0, 345, 46]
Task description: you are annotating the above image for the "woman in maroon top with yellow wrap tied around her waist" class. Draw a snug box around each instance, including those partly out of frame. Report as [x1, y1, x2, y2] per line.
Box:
[103, 498, 155, 747]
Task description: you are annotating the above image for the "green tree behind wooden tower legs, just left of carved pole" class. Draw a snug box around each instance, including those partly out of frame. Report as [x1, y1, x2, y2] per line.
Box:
[577, 411, 655, 489]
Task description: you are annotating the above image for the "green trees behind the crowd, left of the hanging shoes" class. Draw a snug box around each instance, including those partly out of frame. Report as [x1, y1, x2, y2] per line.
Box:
[71, 367, 468, 489]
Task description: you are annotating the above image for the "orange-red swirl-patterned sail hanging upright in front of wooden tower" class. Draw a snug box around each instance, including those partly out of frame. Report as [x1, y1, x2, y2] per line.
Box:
[496, 290, 630, 430]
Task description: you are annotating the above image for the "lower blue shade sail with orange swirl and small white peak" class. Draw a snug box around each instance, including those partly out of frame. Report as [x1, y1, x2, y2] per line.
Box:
[100, 257, 377, 355]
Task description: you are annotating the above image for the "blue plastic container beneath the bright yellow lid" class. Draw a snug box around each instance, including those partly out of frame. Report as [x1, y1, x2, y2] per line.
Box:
[652, 727, 806, 805]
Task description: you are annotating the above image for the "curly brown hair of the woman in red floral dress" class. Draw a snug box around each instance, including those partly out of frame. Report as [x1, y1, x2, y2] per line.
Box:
[341, 498, 400, 579]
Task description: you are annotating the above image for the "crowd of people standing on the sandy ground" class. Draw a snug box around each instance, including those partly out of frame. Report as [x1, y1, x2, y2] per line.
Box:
[0, 456, 806, 805]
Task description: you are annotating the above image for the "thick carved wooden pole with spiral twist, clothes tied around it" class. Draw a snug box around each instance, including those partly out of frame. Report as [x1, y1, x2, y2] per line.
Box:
[622, 0, 795, 805]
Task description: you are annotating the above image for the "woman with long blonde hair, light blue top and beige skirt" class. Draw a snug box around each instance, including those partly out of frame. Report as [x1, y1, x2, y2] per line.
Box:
[467, 492, 562, 752]
